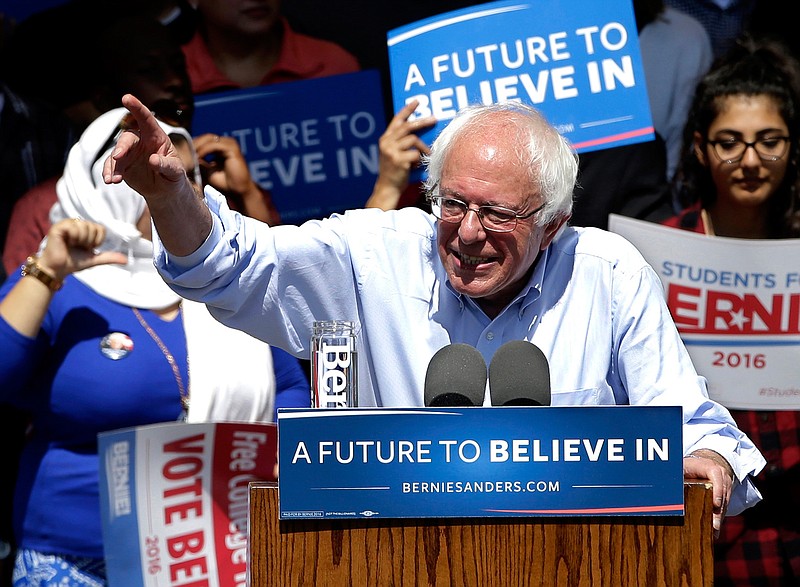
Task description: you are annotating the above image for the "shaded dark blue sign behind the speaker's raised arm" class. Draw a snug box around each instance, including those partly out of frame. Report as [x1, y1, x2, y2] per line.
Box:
[192, 70, 386, 224]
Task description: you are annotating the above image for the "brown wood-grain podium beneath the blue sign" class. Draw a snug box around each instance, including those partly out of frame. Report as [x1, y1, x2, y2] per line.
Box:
[248, 481, 714, 587]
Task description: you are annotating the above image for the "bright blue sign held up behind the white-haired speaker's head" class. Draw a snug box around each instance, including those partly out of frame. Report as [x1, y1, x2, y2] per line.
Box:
[387, 0, 655, 153]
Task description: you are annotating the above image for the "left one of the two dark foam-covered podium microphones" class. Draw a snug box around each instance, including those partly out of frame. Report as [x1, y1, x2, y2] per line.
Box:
[425, 343, 486, 408]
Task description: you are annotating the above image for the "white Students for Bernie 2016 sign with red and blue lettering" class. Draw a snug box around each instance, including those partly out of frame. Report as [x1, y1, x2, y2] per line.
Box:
[609, 214, 800, 410]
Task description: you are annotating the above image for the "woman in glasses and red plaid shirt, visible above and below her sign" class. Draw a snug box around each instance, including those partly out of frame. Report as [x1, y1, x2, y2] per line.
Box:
[664, 38, 800, 587]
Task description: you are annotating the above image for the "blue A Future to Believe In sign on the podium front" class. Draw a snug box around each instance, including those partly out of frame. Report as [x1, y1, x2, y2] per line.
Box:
[278, 406, 683, 520]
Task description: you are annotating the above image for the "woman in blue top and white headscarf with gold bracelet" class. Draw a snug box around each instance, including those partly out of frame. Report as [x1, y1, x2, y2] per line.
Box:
[0, 109, 309, 586]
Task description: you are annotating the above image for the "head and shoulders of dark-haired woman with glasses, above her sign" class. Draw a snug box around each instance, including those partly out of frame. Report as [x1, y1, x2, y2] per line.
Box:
[665, 38, 800, 238]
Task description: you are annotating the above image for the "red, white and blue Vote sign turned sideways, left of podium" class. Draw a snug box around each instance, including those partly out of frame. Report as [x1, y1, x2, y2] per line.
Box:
[98, 422, 278, 587]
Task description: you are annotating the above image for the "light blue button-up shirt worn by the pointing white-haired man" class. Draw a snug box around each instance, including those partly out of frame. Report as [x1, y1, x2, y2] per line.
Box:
[155, 188, 765, 514]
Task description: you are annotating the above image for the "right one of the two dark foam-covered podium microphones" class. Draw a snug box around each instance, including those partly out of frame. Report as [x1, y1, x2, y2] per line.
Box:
[489, 340, 550, 406]
